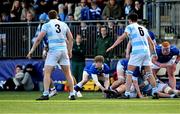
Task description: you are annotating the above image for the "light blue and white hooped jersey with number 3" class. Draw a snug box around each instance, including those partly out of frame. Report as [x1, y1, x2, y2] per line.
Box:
[41, 19, 70, 52]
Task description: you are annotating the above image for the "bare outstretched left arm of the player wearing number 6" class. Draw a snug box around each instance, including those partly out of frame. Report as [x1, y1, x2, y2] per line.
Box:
[106, 33, 127, 52]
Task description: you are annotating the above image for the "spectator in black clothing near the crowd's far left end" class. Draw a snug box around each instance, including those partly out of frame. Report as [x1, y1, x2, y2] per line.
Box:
[10, 0, 22, 22]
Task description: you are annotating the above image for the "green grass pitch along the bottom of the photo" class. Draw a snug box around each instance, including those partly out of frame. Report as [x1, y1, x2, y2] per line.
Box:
[0, 92, 180, 114]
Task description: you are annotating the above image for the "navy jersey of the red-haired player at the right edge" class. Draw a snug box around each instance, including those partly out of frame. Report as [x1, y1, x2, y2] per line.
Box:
[156, 46, 180, 63]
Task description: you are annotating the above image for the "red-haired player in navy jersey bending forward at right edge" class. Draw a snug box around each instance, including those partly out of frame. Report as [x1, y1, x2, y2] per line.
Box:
[152, 41, 180, 89]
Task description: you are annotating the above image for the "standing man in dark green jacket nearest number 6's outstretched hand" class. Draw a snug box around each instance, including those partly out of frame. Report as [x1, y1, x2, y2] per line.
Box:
[94, 26, 113, 65]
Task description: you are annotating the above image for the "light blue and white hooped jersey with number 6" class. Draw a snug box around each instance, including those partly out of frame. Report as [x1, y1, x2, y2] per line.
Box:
[125, 23, 150, 54]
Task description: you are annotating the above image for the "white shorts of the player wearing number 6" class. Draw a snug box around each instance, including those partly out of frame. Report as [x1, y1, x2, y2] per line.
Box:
[128, 54, 151, 66]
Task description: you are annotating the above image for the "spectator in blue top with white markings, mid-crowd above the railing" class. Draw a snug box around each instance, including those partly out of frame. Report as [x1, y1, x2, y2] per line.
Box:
[89, 0, 101, 20]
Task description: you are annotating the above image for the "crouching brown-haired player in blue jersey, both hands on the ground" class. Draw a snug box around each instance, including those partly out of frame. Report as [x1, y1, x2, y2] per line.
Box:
[74, 55, 110, 96]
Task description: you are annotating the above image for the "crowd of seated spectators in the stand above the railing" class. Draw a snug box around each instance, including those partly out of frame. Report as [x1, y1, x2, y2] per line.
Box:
[0, 0, 143, 22]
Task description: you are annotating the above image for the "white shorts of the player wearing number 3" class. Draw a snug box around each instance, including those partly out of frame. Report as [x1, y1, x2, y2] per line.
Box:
[45, 51, 70, 66]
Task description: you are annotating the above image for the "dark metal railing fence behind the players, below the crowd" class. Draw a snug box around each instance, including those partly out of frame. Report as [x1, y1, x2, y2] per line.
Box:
[0, 21, 127, 58]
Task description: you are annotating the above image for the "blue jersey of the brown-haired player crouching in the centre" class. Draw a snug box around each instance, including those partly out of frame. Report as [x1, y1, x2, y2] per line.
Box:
[84, 63, 110, 75]
